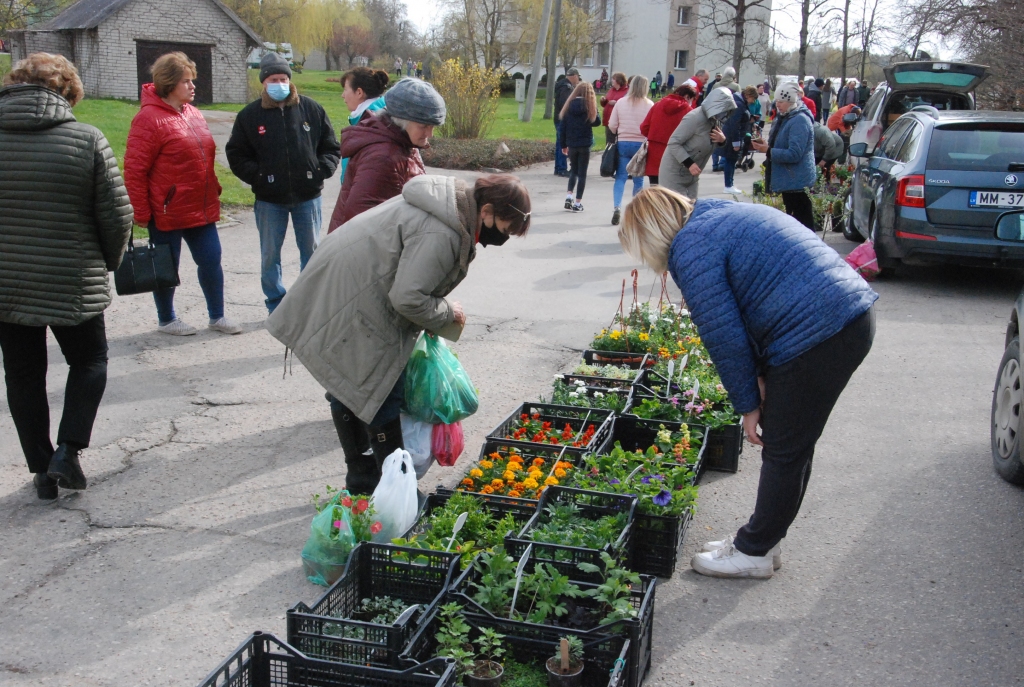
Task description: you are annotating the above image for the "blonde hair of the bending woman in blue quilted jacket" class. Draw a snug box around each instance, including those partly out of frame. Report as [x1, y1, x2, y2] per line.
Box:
[618, 186, 693, 272]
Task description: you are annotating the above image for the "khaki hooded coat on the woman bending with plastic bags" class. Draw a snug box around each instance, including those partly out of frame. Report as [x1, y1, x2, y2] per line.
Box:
[266, 174, 477, 423]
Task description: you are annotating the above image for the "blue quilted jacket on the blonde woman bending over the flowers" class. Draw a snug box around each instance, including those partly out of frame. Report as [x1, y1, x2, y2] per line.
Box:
[669, 199, 879, 413]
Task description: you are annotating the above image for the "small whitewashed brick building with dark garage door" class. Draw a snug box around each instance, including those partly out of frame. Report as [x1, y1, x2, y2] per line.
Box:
[11, 0, 262, 103]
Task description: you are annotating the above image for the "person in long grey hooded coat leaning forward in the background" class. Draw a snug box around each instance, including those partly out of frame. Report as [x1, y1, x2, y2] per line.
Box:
[657, 87, 736, 200]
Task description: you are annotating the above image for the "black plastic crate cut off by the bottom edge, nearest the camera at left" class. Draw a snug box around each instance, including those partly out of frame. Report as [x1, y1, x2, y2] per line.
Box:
[199, 632, 458, 687]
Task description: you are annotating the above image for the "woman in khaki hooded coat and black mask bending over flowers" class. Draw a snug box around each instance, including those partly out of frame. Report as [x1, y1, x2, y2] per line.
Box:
[266, 174, 530, 493]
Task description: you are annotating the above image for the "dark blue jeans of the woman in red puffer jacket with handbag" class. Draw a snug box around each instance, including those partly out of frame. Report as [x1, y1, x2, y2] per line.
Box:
[148, 221, 224, 325]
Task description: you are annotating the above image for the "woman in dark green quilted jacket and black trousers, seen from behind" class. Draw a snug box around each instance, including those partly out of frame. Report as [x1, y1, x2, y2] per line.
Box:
[0, 52, 132, 500]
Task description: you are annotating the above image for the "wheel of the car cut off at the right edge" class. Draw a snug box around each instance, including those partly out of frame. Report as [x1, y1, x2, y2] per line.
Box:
[992, 337, 1024, 485]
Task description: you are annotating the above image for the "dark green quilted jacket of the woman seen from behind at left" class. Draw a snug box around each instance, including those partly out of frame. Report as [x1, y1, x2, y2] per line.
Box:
[0, 85, 132, 327]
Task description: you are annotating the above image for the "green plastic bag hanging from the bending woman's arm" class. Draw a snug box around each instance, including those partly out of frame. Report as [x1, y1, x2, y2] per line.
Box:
[404, 332, 480, 425]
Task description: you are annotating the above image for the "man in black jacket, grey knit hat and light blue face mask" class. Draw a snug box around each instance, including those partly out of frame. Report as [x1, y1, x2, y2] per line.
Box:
[224, 52, 341, 312]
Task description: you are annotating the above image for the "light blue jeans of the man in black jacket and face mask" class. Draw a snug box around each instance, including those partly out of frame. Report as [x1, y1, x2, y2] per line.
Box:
[253, 196, 321, 312]
